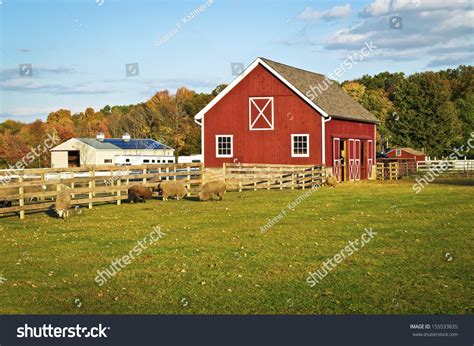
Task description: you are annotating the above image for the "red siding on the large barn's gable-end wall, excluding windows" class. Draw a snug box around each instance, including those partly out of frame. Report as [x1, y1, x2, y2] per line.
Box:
[203, 66, 322, 167]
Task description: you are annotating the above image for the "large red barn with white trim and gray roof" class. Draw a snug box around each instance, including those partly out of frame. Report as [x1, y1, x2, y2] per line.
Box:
[195, 58, 378, 180]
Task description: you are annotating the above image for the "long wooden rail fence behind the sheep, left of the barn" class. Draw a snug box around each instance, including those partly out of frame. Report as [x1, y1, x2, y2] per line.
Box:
[0, 163, 202, 219]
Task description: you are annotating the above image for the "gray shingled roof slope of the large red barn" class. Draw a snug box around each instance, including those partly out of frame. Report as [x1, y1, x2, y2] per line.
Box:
[260, 58, 379, 123]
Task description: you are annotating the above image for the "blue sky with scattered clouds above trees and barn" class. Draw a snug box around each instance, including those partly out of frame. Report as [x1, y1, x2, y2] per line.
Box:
[0, 0, 474, 122]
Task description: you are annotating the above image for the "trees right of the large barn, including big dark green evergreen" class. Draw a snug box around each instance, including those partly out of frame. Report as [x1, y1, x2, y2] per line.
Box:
[342, 65, 474, 158]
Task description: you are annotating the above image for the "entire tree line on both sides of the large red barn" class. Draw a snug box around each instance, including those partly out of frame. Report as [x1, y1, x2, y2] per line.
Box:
[0, 65, 474, 168]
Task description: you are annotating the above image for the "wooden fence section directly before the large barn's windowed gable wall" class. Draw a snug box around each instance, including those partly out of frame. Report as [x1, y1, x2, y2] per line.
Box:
[223, 163, 325, 191]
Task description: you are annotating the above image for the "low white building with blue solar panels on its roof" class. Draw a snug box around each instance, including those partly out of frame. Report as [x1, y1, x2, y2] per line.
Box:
[51, 133, 175, 168]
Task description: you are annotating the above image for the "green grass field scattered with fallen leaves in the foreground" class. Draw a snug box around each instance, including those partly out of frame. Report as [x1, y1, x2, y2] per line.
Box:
[0, 179, 474, 314]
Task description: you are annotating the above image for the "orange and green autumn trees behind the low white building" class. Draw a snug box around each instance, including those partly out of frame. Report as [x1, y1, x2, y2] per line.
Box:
[0, 85, 225, 168]
